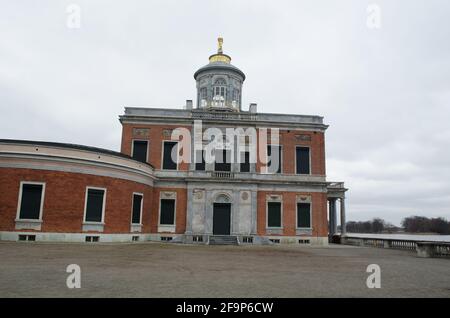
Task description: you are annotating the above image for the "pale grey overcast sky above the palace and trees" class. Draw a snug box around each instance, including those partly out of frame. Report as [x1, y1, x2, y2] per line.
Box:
[0, 0, 450, 224]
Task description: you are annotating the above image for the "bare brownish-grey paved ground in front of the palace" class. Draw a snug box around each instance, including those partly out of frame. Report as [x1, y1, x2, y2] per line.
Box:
[0, 242, 450, 297]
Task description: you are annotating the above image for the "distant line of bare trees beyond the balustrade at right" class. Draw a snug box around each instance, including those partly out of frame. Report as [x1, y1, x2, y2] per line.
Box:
[346, 216, 450, 234]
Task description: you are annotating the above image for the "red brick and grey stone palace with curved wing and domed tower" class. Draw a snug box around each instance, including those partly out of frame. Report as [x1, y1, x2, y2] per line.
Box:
[0, 38, 347, 245]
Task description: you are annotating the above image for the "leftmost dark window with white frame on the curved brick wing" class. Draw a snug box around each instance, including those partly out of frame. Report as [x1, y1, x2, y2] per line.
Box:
[18, 183, 45, 220]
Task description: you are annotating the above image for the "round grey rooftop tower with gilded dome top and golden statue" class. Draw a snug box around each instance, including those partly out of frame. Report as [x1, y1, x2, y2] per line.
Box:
[194, 38, 245, 111]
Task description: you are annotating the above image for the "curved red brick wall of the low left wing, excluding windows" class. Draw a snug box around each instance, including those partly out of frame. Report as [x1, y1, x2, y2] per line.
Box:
[0, 168, 153, 233]
